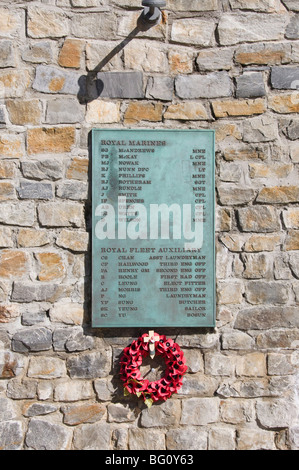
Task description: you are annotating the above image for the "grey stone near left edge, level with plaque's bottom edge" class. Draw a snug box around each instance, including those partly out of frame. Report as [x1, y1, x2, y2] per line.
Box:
[12, 328, 52, 352]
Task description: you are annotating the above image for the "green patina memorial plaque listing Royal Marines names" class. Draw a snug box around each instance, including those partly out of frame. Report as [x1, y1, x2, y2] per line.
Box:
[92, 129, 215, 328]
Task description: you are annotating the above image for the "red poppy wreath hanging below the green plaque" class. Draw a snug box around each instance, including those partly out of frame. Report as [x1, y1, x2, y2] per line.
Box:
[120, 333, 187, 407]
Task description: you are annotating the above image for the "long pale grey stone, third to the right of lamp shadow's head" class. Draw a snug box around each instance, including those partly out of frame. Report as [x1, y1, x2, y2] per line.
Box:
[175, 72, 233, 99]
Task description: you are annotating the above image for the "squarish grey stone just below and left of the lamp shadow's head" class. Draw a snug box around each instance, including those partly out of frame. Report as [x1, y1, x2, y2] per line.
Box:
[46, 98, 85, 124]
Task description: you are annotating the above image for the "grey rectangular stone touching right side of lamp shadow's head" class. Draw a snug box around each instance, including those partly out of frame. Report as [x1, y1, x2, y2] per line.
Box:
[97, 72, 144, 98]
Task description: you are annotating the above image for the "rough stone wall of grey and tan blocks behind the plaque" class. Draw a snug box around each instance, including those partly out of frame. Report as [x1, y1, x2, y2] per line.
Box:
[0, 0, 299, 450]
